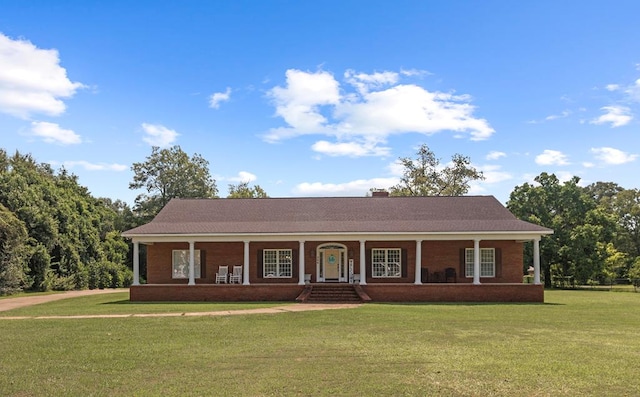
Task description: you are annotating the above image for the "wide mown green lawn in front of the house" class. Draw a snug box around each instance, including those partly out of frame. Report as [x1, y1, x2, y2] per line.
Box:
[0, 291, 640, 396]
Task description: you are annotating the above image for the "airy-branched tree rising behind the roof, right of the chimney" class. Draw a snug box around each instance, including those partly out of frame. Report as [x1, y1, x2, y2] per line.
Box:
[389, 144, 484, 196]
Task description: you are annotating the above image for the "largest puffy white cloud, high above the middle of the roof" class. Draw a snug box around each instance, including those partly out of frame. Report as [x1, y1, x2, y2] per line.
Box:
[264, 69, 494, 157]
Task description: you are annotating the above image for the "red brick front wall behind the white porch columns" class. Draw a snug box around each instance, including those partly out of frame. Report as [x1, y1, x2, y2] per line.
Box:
[147, 240, 523, 285]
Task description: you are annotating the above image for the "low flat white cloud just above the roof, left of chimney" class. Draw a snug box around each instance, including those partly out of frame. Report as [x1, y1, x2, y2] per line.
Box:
[293, 178, 399, 197]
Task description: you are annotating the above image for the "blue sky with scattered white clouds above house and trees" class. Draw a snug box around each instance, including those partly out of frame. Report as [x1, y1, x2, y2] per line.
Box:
[0, 0, 640, 204]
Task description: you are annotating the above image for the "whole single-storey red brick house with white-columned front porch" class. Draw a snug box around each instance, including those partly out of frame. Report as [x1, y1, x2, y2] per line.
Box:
[123, 193, 553, 302]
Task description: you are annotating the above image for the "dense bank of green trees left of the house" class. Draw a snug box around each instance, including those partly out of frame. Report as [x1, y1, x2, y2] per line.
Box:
[0, 150, 129, 290]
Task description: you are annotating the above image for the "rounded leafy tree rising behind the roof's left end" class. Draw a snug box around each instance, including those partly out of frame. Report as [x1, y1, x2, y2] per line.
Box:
[129, 146, 218, 221]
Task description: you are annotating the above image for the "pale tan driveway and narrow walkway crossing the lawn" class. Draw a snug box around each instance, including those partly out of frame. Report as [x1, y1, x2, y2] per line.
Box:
[0, 289, 361, 320]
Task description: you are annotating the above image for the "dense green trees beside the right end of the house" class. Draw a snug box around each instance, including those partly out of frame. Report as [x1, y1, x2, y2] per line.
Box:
[507, 173, 634, 286]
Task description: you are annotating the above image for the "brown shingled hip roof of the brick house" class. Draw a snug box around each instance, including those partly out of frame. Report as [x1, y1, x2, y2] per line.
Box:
[123, 196, 552, 237]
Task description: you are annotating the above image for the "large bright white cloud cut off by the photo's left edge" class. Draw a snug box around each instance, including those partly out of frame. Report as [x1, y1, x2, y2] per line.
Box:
[0, 33, 84, 119]
